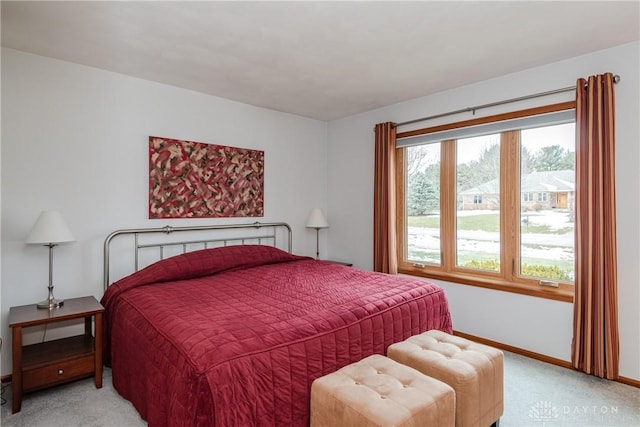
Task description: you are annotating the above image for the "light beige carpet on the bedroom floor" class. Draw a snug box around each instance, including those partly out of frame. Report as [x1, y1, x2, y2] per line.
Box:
[1, 353, 640, 427]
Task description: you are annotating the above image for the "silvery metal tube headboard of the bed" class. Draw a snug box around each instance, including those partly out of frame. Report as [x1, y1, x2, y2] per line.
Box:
[104, 222, 292, 290]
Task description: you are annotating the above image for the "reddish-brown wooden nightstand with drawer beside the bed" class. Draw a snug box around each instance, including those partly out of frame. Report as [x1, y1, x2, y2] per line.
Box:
[9, 297, 104, 414]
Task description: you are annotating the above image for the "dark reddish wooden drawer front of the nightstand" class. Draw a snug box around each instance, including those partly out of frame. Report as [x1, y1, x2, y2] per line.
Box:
[22, 354, 95, 392]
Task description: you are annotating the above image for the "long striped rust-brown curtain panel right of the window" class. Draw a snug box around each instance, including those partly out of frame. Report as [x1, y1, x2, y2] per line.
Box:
[571, 73, 619, 379]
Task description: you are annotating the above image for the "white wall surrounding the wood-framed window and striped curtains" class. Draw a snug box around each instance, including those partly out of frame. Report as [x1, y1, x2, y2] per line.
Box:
[328, 42, 640, 379]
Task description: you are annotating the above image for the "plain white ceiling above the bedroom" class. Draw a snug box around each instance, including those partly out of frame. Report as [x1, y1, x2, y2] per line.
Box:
[1, 1, 640, 120]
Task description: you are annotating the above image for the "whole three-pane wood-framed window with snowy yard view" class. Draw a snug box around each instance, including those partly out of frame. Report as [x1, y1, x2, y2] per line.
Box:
[396, 103, 575, 300]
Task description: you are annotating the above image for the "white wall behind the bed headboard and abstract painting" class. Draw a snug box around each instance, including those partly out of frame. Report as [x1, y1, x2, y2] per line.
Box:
[0, 49, 327, 375]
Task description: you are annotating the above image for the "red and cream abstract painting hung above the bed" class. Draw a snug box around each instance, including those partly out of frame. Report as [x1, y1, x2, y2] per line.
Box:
[149, 136, 264, 219]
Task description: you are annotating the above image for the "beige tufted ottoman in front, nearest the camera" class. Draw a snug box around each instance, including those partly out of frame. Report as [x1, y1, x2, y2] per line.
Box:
[311, 354, 455, 427]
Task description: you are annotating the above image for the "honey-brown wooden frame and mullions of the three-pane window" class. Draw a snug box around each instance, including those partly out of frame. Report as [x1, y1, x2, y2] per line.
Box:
[395, 101, 576, 302]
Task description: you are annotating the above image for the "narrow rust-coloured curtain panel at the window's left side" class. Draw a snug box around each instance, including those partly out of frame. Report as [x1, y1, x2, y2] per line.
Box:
[373, 122, 398, 274]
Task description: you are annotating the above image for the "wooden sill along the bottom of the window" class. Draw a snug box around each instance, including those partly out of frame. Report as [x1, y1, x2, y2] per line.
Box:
[398, 268, 574, 303]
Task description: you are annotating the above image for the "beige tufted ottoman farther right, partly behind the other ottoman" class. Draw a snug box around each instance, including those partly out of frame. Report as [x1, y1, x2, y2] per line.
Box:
[387, 330, 504, 427]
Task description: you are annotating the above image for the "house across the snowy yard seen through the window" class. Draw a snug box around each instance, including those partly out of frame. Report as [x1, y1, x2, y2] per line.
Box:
[458, 170, 576, 211]
